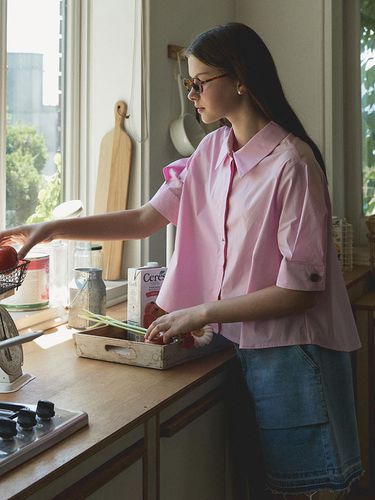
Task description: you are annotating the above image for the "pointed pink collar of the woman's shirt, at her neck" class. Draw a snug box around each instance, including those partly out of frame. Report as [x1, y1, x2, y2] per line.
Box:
[216, 121, 289, 176]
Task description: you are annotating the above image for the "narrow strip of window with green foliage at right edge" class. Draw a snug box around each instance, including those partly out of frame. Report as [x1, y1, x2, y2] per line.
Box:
[361, 0, 375, 215]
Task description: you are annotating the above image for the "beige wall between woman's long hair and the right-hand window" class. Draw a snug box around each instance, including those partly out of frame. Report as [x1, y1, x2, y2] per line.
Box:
[236, 0, 344, 216]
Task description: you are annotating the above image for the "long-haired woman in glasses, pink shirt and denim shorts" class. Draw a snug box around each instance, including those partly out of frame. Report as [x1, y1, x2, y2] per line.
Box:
[0, 23, 362, 499]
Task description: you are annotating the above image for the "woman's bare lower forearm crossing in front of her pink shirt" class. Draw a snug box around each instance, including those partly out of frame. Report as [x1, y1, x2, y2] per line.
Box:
[198, 286, 317, 323]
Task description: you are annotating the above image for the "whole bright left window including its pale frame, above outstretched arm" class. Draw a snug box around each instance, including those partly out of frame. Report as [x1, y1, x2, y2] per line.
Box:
[0, 0, 87, 227]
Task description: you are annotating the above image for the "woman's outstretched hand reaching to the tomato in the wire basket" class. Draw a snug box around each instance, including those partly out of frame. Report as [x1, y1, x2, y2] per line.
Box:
[0, 221, 54, 259]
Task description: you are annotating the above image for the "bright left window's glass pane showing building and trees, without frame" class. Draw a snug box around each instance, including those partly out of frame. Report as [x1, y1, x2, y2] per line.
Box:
[6, 0, 65, 227]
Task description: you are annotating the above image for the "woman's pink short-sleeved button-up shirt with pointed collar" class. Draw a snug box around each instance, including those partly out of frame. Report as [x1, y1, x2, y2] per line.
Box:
[151, 122, 360, 351]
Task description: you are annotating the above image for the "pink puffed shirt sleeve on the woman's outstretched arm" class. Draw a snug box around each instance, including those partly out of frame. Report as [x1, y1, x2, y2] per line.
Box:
[150, 158, 189, 225]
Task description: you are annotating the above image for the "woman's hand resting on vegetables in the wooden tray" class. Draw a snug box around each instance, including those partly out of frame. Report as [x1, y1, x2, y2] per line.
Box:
[145, 306, 206, 344]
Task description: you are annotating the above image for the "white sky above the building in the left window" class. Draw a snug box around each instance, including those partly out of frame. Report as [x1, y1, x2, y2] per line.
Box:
[7, 0, 60, 106]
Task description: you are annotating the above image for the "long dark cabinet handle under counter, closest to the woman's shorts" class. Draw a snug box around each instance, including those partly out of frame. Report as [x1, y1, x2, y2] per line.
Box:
[160, 388, 223, 437]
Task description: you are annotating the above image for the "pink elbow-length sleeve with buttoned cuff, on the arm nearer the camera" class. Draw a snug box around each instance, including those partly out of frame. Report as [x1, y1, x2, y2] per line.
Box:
[276, 162, 330, 291]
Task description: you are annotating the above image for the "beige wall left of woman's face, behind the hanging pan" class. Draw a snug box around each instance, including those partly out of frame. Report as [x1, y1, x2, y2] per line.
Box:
[143, 0, 235, 262]
